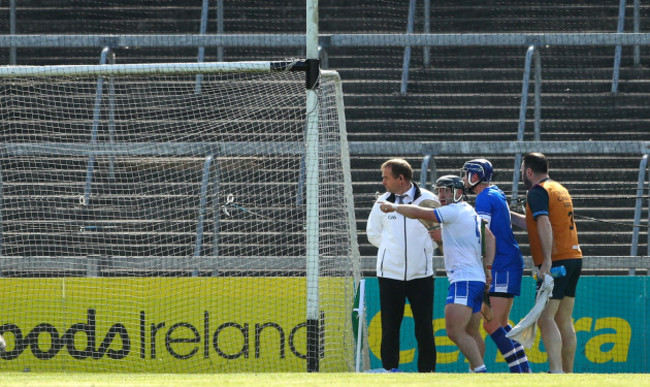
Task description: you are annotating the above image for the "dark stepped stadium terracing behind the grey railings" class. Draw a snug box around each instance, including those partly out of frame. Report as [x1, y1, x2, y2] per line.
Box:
[0, 0, 650, 274]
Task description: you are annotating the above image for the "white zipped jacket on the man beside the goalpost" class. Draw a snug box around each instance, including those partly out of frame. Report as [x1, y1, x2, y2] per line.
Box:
[366, 183, 438, 281]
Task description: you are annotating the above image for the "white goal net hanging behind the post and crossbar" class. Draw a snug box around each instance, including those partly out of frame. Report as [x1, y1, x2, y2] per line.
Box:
[0, 61, 359, 372]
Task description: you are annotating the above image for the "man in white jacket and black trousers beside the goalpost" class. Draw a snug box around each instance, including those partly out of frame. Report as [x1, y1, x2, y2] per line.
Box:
[366, 159, 440, 372]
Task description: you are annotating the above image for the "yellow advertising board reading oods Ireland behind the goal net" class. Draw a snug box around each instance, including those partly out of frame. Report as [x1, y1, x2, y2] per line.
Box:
[0, 277, 351, 372]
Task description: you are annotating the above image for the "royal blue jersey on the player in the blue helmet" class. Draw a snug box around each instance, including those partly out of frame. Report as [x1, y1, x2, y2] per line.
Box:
[475, 185, 524, 271]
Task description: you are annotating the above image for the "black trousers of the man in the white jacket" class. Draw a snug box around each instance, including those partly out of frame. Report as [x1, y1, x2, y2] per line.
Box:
[378, 277, 436, 372]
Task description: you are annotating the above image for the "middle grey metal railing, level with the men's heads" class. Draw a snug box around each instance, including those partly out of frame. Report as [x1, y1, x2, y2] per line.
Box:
[0, 141, 650, 266]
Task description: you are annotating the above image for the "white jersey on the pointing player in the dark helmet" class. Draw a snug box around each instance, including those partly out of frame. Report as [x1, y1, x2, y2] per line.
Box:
[434, 201, 485, 283]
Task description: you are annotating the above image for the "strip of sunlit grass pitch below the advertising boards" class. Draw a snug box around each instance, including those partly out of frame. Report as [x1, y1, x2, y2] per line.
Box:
[0, 372, 650, 387]
